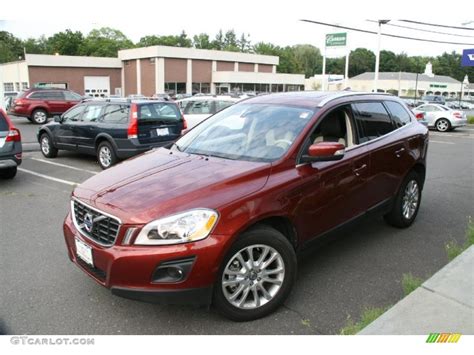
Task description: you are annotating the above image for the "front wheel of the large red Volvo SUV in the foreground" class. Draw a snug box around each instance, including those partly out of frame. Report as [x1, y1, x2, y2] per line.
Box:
[213, 226, 297, 322]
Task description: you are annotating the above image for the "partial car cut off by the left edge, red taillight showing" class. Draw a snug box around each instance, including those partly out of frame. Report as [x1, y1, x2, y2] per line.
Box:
[0, 108, 22, 179]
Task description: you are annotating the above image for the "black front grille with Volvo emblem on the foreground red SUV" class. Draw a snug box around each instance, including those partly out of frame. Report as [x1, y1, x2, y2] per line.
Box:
[72, 200, 120, 246]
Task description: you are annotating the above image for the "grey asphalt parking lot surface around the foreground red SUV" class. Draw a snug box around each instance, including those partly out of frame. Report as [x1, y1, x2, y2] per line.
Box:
[0, 118, 474, 334]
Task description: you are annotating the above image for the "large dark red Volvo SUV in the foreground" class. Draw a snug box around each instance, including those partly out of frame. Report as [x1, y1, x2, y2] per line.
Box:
[64, 92, 428, 321]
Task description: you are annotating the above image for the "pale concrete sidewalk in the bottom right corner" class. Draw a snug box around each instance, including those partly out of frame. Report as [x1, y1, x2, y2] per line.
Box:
[359, 246, 474, 335]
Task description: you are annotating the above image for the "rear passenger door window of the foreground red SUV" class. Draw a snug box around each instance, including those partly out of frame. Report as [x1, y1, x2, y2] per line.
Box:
[352, 102, 395, 143]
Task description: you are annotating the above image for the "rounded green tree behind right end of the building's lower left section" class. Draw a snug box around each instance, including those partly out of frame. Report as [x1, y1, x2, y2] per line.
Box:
[80, 27, 133, 57]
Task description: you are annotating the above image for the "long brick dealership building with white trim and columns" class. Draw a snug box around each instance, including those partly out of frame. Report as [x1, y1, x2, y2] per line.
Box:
[0, 46, 305, 101]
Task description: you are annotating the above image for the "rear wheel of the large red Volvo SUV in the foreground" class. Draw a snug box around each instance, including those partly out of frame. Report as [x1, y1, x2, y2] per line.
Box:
[384, 171, 422, 228]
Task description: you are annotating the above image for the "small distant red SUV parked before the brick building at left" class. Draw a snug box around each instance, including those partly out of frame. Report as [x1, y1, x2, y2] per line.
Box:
[10, 88, 83, 124]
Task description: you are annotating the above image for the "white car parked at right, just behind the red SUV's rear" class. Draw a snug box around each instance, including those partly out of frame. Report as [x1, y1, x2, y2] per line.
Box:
[413, 104, 467, 132]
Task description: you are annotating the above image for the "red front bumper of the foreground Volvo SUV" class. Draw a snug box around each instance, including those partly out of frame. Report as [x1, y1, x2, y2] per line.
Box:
[63, 214, 228, 304]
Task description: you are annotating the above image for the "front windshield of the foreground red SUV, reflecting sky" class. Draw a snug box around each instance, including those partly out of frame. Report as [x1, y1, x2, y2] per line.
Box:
[172, 103, 314, 162]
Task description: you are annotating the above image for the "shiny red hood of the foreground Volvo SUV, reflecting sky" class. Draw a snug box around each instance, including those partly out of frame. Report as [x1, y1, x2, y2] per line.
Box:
[73, 148, 271, 224]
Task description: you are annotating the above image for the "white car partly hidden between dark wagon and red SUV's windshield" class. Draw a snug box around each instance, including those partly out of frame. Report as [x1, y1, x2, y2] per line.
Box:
[176, 95, 242, 129]
